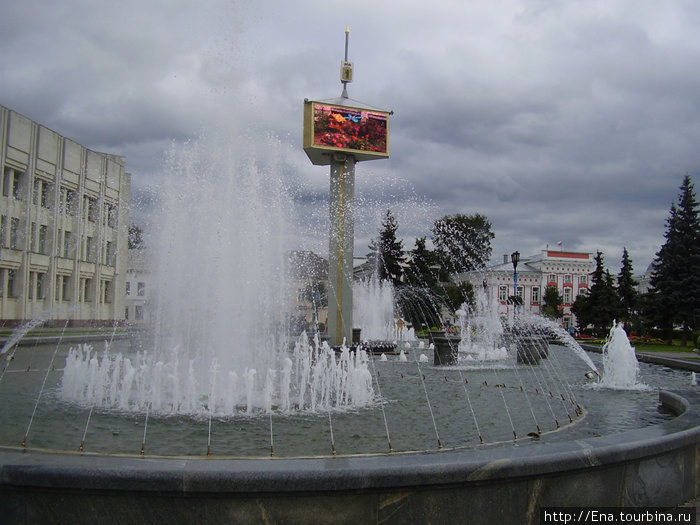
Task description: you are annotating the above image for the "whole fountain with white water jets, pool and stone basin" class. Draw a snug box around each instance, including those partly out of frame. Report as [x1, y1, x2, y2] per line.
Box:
[0, 128, 700, 523]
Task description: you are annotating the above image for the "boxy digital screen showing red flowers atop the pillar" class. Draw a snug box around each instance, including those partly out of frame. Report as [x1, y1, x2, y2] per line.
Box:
[304, 102, 389, 164]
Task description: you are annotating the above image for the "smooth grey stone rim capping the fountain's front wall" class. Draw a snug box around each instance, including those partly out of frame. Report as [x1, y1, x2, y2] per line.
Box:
[0, 391, 700, 504]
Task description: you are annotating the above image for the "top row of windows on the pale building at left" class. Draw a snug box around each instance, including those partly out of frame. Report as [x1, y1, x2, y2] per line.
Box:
[3, 168, 119, 228]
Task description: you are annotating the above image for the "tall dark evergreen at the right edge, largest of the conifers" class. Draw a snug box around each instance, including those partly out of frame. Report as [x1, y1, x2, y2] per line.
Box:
[647, 175, 700, 346]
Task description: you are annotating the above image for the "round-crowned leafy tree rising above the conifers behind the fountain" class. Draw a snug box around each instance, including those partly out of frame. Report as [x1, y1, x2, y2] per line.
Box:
[431, 213, 494, 273]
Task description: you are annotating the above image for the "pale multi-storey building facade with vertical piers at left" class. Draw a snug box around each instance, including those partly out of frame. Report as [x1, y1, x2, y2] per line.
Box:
[0, 106, 131, 325]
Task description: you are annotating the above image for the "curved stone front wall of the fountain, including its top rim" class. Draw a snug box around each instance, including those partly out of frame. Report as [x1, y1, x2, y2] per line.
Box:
[0, 391, 700, 523]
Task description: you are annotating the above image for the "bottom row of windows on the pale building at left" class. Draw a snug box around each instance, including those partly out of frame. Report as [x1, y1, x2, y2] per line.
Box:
[0, 268, 114, 303]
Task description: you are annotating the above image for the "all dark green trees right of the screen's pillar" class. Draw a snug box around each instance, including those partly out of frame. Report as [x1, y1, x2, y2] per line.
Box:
[367, 176, 700, 346]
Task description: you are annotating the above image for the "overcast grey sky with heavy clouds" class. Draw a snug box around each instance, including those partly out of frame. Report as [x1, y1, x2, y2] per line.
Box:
[0, 0, 700, 273]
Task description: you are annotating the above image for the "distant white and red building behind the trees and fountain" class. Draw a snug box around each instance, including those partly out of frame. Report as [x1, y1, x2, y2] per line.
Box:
[455, 250, 595, 328]
